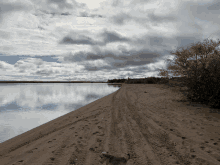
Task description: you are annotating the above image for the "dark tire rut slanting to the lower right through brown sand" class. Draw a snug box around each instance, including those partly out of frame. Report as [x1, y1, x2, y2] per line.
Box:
[126, 85, 189, 164]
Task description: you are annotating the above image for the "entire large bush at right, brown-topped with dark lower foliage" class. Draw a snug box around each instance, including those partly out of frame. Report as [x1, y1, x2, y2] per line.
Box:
[157, 39, 220, 107]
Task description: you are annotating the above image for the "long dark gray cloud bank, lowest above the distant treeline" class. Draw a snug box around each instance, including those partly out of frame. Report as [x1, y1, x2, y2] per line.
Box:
[63, 47, 161, 71]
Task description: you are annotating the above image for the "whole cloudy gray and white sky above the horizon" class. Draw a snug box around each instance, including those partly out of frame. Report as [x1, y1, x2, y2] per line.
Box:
[0, 0, 220, 81]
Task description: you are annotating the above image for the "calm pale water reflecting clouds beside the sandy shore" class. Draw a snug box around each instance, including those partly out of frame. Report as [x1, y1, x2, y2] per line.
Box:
[0, 83, 120, 143]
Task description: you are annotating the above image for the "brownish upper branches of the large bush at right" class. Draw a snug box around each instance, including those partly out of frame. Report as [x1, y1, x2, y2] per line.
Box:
[161, 39, 220, 78]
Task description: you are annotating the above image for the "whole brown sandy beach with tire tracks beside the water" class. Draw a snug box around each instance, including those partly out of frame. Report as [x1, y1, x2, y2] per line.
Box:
[0, 84, 220, 165]
